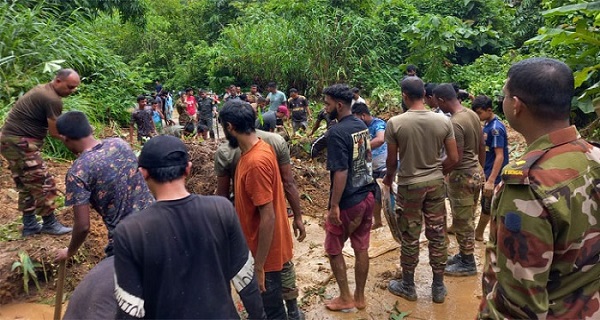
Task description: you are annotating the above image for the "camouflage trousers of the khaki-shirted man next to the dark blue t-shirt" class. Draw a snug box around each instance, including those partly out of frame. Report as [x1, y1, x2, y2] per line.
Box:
[448, 168, 484, 255]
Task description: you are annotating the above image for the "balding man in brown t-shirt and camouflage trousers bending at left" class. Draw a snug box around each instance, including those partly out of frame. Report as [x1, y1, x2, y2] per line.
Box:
[0, 69, 80, 237]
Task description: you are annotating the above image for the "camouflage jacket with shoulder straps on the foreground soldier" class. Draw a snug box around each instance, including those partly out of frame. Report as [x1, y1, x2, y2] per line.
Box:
[479, 126, 600, 319]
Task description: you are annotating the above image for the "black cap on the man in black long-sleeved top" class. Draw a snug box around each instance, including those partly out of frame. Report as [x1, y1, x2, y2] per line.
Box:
[138, 135, 189, 169]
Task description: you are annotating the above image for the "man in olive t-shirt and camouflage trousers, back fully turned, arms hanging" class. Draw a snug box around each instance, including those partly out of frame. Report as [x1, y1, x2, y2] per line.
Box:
[383, 77, 458, 303]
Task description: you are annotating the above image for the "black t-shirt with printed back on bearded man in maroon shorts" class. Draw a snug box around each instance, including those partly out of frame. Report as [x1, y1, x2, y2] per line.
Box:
[327, 115, 374, 209]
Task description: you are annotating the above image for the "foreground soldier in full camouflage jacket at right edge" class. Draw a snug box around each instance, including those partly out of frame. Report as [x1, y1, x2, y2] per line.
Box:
[478, 58, 600, 319]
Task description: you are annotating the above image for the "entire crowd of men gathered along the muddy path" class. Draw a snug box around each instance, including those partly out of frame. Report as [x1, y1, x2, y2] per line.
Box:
[0, 58, 600, 319]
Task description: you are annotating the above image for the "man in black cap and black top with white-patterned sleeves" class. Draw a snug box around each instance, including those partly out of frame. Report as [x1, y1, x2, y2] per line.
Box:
[114, 136, 264, 319]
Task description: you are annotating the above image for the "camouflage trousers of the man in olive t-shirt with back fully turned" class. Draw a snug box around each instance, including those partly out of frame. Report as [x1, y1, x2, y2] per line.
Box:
[396, 179, 448, 273]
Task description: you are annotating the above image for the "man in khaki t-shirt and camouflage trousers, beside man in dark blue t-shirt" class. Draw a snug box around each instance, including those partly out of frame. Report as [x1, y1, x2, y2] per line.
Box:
[433, 83, 485, 276]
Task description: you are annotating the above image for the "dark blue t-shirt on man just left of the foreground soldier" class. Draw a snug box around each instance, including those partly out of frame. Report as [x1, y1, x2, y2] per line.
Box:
[483, 116, 508, 184]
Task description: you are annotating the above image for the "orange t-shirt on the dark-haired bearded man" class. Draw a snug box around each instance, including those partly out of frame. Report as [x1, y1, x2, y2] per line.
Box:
[234, 140, 293, 272]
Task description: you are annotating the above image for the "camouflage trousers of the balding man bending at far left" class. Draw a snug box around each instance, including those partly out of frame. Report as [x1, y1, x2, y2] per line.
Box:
[0, 135, 58, 216]
